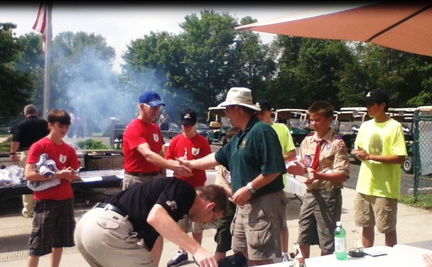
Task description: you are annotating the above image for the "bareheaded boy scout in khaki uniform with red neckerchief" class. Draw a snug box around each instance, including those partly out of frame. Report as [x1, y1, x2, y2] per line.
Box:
[288, 101, 349, 258]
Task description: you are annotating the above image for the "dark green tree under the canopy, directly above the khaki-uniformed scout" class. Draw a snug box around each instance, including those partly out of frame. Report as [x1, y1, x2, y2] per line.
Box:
[270, 36, 355, 108]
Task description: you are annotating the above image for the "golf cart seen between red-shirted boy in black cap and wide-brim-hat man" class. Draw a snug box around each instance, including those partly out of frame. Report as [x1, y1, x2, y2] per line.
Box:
[207, 107, 232, 145]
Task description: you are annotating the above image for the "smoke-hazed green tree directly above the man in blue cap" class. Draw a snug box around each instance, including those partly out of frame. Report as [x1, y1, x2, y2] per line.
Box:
[122, 32, 187, 120]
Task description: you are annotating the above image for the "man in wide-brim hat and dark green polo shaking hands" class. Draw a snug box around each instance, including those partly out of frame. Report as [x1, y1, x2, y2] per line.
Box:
[177, 87, 286, 266]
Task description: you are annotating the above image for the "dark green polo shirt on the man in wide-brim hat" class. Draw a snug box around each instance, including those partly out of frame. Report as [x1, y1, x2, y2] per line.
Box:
[215, 116, 286, 196]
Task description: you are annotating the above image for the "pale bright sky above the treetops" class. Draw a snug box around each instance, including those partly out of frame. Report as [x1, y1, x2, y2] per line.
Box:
[0, 4, 300, 71]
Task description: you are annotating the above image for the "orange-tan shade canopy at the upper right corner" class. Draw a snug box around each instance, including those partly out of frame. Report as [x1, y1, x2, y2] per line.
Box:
[236, 2, 432, 56]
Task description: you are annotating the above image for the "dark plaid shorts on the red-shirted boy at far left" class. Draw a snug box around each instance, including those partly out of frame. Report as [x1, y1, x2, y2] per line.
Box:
[29, 198, 75, 256]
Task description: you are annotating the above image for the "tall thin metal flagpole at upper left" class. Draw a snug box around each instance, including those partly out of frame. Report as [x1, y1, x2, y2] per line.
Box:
[43, 0, 52, 119]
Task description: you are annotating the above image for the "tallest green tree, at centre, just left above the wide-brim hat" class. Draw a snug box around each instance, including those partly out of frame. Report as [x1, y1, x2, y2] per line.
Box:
[180, 10, 241, 110]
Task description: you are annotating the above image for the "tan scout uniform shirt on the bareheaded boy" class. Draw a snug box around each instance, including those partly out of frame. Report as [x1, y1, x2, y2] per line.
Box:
[299, 129, 349, 190]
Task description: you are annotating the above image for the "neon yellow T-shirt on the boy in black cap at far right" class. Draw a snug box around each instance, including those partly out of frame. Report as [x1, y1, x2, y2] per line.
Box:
[355, 119, 407, 199]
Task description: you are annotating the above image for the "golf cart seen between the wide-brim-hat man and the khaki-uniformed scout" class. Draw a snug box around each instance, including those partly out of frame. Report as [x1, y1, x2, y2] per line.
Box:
[274, 108, 311, 146]
